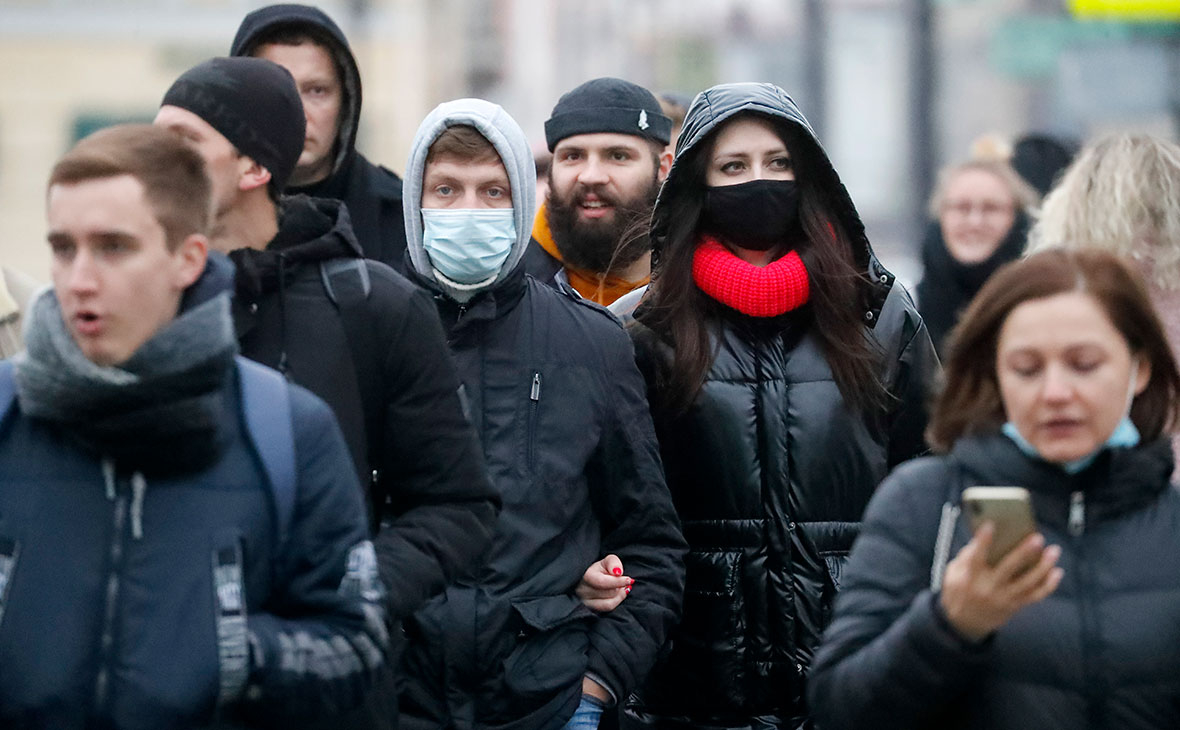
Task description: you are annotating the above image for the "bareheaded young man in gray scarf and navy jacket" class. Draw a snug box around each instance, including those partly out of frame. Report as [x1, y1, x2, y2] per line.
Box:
[0, 125, 387, 729]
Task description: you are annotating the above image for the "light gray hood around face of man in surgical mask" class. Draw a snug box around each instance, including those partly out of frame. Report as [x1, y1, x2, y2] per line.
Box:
[402, 99, 537, 300]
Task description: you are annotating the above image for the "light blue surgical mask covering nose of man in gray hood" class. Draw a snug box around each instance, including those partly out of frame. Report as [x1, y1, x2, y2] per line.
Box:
[422, 208, 516, 284]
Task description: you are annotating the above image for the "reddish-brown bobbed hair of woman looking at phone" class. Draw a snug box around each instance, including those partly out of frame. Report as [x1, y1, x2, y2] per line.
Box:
[926, 249, 1180, 452]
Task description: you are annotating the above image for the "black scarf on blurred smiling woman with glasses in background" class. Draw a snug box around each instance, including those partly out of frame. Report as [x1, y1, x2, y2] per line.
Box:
[918, 211, 1029, 356]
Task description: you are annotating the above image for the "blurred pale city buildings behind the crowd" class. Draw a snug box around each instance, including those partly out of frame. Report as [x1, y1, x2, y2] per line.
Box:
[0, 0, 1180, 283]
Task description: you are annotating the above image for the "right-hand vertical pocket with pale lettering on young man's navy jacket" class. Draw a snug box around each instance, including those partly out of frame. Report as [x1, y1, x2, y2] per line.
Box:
[212, 532, 250, 706]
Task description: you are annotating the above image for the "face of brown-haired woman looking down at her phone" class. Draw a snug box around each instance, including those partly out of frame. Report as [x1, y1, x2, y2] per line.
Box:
[996, 291, 1151, 463]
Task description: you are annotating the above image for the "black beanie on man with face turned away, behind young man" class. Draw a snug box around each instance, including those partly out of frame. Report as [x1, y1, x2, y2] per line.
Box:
[160, 58, 307, 190]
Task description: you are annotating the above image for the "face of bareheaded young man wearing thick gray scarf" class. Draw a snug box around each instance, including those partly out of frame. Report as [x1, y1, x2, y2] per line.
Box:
[47, 175, 207, 366]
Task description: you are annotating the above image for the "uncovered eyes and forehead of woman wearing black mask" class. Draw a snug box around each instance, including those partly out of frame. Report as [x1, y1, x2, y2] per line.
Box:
[704, 117, 795, 188]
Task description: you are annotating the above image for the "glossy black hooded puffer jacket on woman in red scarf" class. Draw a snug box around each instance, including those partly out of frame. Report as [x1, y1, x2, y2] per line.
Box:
[631, 84, 937, 726]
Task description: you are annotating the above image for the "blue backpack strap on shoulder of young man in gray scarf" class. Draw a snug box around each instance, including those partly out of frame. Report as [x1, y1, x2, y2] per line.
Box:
[236, 356, 296, 546]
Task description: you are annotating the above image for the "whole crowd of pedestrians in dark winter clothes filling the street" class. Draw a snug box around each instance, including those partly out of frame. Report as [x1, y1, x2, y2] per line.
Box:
[0, 5, 1180, 730]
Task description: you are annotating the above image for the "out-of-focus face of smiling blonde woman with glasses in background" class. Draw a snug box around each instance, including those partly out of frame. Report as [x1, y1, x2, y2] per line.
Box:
[938, 170, 1016, 264]
